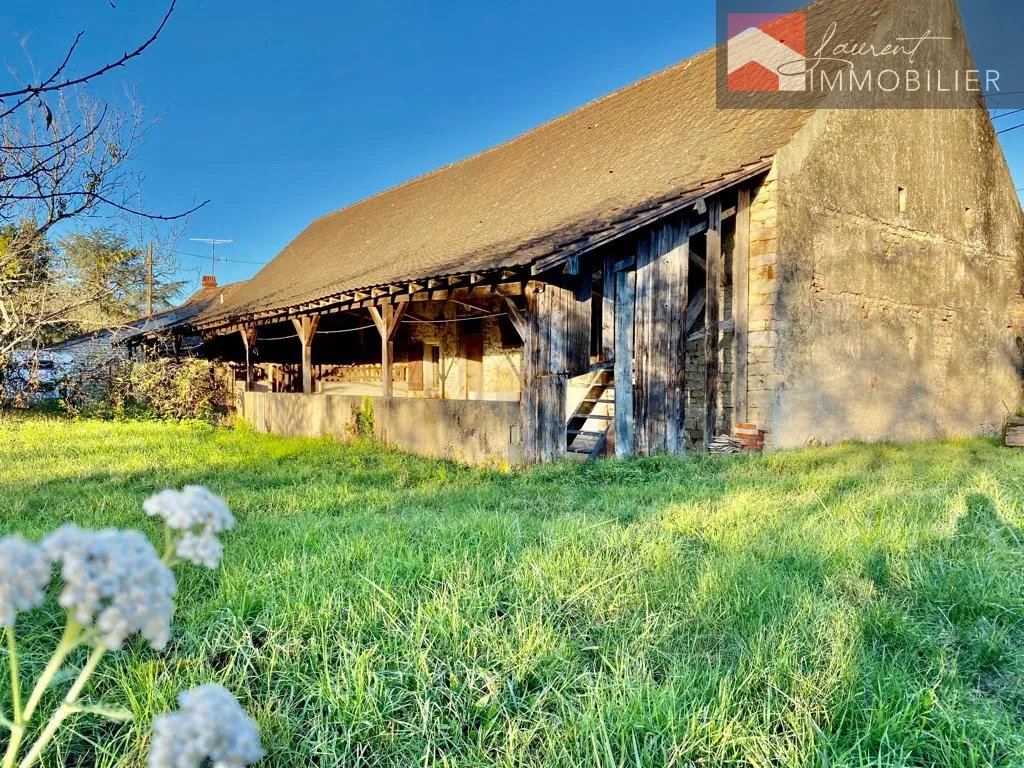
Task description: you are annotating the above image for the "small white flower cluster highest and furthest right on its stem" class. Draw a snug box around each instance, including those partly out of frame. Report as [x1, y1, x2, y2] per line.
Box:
[142, 485, 234, 568]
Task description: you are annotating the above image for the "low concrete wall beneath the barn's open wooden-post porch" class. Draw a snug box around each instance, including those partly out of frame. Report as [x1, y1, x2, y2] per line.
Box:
[239, 392, 522, 464]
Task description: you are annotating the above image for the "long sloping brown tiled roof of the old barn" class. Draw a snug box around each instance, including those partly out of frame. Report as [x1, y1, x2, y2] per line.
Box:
[196, 0, 901, 328]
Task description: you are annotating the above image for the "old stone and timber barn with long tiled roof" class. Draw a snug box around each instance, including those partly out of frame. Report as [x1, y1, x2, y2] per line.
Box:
[172, 0, 1024, 463]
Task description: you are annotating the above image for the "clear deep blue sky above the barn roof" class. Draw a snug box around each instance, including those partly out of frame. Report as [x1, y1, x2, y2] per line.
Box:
[0, 0, 1024, 294]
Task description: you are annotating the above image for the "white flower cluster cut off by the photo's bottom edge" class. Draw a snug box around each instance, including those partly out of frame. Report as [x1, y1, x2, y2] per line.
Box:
[150, 685, 264, 768]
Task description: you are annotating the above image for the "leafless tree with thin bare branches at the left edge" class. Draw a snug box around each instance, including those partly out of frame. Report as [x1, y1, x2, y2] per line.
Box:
[0, 0, 206, 397]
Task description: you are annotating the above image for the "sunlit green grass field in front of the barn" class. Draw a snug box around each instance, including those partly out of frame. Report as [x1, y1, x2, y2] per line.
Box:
[0, 420, 1024, 768]
